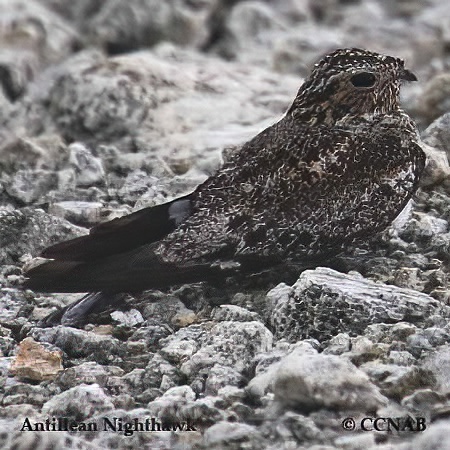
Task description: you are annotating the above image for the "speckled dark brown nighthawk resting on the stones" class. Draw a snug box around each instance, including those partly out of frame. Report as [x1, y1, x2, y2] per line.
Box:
[24, 48, 426, 324]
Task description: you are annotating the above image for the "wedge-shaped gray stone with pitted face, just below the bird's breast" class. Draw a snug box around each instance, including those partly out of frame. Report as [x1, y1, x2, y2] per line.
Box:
[267, 267, 443, 342]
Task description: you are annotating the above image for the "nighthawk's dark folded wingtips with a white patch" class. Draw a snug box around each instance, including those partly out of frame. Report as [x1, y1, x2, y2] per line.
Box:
[24, 193, 200, 292]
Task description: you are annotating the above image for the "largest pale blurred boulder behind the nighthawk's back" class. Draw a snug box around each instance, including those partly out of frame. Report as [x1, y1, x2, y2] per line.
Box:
[10, 44, 299, 172]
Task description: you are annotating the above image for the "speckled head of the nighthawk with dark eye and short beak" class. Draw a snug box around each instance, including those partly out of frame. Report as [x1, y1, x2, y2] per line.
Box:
[288, 48, 417, 126]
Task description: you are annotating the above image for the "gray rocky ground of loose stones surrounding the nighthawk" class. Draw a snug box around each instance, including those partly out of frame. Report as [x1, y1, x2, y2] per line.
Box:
[0, 0, 450, 450]
